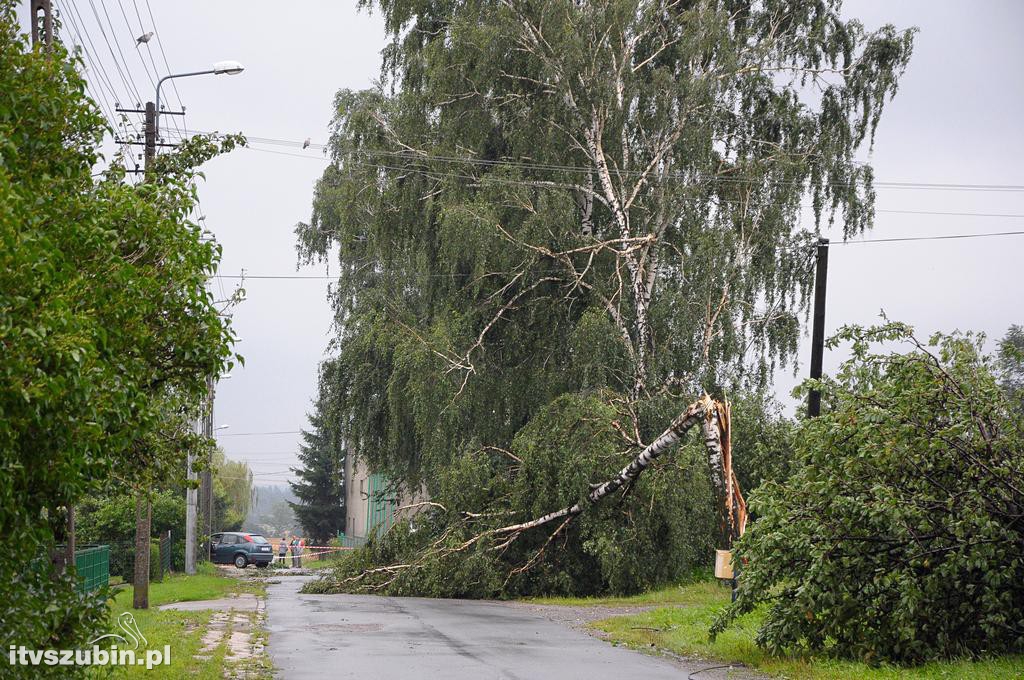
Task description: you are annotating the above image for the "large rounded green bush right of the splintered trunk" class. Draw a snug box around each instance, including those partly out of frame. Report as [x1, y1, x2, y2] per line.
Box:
[715, 323, 1024, 663]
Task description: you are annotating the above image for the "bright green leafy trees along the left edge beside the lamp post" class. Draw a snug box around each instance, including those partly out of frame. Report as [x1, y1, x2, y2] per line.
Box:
[0, 0, 238, 655]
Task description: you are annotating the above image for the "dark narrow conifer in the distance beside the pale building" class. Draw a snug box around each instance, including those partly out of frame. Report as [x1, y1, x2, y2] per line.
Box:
[288, 360, 346, 542]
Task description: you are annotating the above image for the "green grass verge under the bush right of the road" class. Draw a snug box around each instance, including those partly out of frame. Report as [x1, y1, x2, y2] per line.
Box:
[569, 581, 1024, 680]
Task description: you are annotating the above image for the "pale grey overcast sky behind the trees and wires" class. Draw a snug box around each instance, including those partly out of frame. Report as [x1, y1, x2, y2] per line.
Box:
[19, 0, 1024, 483]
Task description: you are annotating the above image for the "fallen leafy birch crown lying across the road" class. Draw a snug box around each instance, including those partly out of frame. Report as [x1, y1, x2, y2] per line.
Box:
[311, 392, 798, 597]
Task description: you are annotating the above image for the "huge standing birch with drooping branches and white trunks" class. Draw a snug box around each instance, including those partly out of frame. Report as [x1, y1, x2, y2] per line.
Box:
[297, 0, 912, 593]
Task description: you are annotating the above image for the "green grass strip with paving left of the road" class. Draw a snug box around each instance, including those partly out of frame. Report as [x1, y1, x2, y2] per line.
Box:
[101, 564, 262, 680]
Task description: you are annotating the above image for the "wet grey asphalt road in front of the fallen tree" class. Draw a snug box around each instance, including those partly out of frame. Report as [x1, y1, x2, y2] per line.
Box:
[267, 577, 761, 680]
